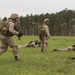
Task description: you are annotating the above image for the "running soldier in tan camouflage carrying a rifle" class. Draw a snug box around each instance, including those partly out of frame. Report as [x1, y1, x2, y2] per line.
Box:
[0, 13, 23, 61]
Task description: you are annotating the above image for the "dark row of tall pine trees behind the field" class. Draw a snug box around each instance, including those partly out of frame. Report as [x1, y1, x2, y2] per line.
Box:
[0, 9, 75, 36]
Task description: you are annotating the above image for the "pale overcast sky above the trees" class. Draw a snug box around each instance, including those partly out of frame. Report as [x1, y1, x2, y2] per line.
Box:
[0, 0, 75, 18]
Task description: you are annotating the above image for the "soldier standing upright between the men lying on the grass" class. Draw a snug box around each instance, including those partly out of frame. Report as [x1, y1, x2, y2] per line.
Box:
[39, 18, 50, 52]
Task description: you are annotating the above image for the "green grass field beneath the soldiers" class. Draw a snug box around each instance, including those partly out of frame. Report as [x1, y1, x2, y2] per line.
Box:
[0, 36, 75, 75]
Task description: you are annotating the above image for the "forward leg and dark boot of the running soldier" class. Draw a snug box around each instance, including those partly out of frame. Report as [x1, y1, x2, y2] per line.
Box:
[7, 38, 18, 60]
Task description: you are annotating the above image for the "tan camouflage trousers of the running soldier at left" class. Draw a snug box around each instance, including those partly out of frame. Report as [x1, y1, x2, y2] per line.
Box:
[0, 35, 18, 56]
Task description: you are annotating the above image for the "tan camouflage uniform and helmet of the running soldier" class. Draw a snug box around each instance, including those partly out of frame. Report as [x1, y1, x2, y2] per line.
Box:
[0, 13, 19, 60]
